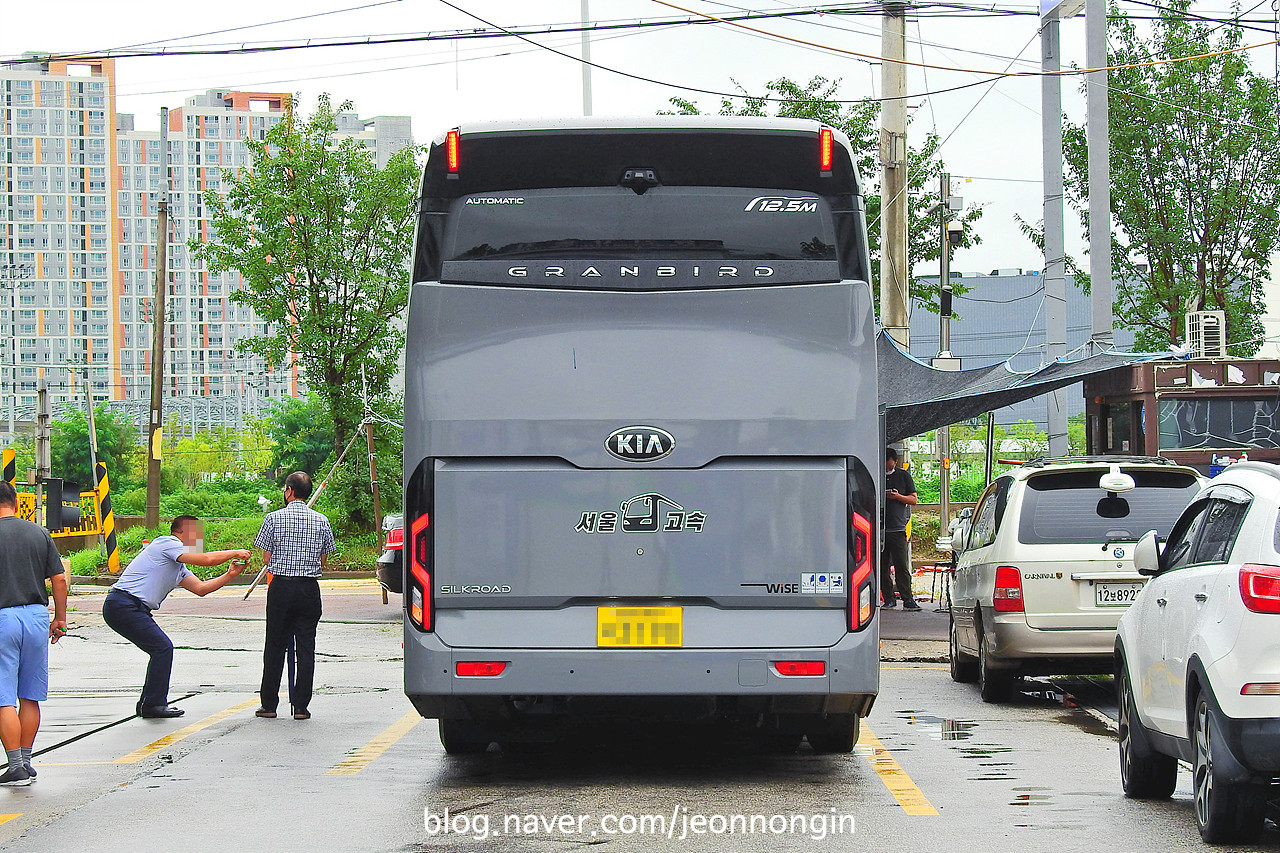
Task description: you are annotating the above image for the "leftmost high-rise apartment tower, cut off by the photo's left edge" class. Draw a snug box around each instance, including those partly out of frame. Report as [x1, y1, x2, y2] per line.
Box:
[0, 60, 120, 429]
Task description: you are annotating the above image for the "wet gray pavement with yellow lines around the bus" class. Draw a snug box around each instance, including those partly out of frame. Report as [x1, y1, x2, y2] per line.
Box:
[0, 584, 1280, 853]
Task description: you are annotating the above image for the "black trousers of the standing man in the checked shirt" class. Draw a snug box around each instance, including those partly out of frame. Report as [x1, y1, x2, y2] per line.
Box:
[261, 576, 320, 711]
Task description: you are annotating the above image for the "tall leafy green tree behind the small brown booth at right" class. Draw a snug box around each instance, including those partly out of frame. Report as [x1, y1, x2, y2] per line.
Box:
[1064, 0, 1280, 355]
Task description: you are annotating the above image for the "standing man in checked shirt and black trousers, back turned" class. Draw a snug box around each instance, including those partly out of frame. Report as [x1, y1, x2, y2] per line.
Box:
[253, 471, 338, 720]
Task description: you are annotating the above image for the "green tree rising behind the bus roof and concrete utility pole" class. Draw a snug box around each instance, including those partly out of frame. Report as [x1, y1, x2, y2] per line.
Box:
[671, 77, 982, 314]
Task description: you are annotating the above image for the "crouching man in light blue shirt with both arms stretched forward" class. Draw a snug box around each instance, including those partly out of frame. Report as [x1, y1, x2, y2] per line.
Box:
[102, 515, 250, 719]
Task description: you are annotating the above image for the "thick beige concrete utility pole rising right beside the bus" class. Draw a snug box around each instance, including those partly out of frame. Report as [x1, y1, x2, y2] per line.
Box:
[879, 3, 911, 347]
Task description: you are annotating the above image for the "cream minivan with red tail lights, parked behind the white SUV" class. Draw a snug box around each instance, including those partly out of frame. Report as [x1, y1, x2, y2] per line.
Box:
[950, 456, 1201, 702]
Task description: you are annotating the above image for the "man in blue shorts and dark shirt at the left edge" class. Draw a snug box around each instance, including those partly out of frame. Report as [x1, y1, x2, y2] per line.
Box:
[0, 480, 67, 786]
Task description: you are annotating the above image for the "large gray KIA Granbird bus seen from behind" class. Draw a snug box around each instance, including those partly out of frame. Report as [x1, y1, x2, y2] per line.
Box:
[404, 117, 883, 754]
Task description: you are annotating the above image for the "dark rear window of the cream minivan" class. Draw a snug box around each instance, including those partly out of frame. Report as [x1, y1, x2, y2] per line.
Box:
[1018, 469, 1199, 547]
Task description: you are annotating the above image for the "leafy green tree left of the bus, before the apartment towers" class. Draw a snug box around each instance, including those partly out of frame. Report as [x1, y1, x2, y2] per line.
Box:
[189, 96, 419, 446]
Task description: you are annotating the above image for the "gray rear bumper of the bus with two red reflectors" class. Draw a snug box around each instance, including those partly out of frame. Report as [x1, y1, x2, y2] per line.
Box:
[404, 626, 879, 721]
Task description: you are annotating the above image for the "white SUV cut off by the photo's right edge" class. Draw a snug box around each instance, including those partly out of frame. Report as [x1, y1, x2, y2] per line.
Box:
[1115, 462, 1280, 843]
